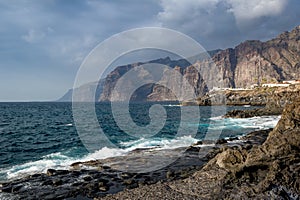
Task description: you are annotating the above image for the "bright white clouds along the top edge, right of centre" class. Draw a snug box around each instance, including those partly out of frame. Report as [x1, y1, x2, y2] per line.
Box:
[158, 0, 287, 27]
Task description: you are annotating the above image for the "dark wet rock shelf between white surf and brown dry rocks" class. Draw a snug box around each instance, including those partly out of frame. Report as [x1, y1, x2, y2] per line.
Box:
[0, 127, 271, 199]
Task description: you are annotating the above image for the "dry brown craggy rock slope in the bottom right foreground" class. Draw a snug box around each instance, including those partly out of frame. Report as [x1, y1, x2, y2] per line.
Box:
[104, 97, 300, 199]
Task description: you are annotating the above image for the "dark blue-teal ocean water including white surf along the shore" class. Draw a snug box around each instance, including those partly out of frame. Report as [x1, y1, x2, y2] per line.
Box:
[0, 102, 280, 181]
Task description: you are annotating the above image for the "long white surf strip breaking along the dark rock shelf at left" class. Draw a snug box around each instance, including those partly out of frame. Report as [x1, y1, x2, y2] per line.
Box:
[0, 136, 197, 179]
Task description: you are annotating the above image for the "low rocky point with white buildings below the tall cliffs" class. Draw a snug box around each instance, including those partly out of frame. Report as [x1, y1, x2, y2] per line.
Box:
[181, 84, 300, 108]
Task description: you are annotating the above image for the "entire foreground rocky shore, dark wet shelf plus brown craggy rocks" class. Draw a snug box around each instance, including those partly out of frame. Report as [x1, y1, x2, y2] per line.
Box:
[0, 90, 300, 199]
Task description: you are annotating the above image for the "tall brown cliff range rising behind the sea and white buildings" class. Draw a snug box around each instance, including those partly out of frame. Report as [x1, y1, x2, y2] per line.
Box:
[58, 26, 300, 101]
